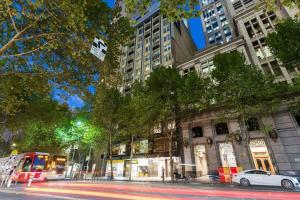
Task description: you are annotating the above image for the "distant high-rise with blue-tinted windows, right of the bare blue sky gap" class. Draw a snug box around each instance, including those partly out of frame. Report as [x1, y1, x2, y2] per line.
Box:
[200, 0, 235, 46]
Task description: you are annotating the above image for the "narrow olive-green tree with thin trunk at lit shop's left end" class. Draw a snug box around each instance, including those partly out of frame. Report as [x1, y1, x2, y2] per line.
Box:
[93, 84, 122, 179]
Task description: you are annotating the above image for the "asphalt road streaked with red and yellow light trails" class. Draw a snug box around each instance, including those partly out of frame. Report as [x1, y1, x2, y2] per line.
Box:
[0, 181, 300, 200]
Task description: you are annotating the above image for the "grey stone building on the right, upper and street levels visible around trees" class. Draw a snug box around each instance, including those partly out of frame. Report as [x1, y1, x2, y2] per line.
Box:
[173, 0, 300, 177]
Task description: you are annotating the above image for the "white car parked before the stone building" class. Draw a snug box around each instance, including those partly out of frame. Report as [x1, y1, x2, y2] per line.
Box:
[232, 170, 300, 189]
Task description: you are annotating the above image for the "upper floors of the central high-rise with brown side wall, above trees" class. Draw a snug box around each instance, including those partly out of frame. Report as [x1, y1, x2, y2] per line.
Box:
[120, 1, 196, 93]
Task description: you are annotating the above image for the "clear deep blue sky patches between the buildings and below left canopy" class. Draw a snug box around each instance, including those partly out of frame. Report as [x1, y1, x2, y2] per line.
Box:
[63, 0, 205, 109]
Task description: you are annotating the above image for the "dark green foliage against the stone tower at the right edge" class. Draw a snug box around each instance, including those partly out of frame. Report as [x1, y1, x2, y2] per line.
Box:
[266, 18, 300, 68]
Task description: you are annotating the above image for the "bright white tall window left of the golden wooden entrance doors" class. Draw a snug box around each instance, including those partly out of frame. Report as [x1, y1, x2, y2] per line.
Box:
[219, 142, 237, 167]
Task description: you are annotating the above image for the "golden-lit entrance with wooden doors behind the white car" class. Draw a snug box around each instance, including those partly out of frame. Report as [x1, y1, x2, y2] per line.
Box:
[250, 139, 275, 174]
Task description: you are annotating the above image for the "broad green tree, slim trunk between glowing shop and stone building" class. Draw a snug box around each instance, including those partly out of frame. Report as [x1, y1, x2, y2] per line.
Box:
[145, 67, 209, 180]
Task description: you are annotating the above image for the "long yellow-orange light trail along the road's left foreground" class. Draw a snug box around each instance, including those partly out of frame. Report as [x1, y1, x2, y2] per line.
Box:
[25, 188, 177, 200]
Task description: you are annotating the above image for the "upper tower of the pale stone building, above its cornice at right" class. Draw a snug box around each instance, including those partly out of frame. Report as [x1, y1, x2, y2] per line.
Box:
[228, 0, 299, 83]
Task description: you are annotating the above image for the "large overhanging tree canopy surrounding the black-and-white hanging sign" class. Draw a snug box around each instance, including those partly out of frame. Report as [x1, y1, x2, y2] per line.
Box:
[0, 0, 131, 122]
